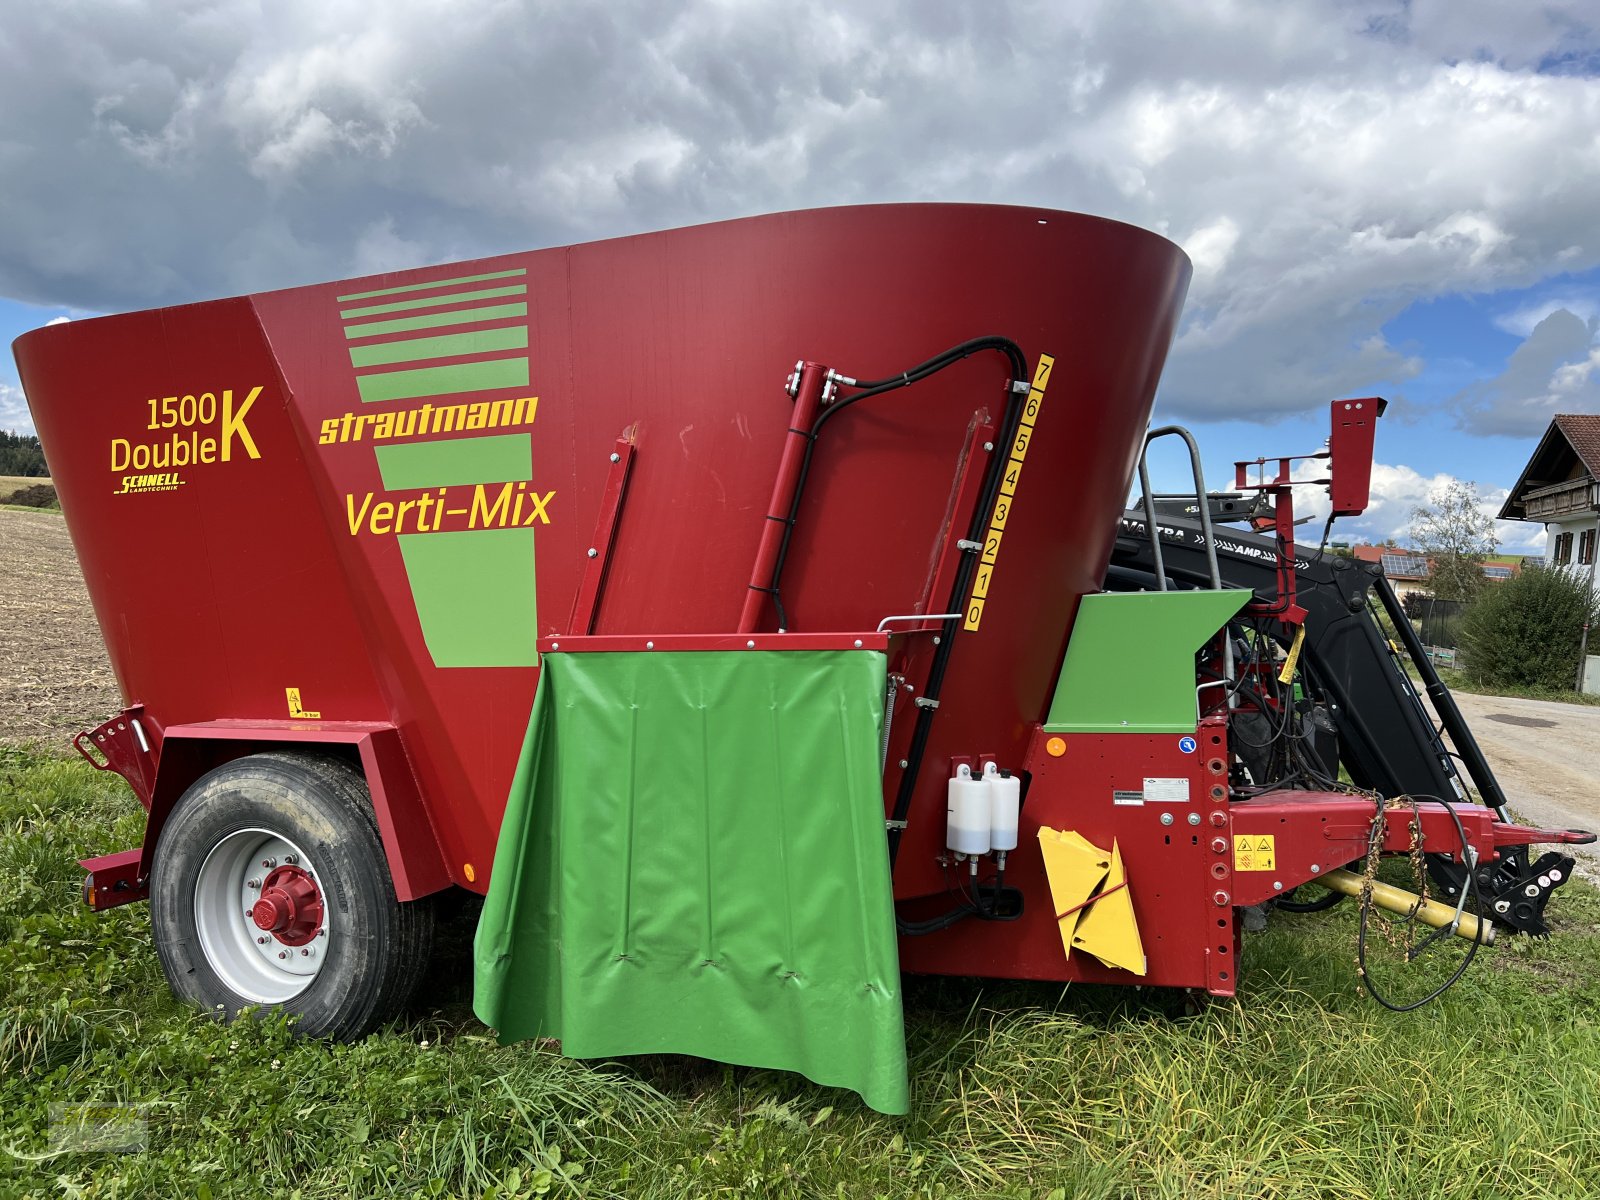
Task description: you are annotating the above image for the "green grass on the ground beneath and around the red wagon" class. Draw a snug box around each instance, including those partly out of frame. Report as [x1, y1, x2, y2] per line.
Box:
[0, 750, 1600, 1200]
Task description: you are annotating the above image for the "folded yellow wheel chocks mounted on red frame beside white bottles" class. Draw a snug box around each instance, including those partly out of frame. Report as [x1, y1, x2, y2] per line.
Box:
[1038, 826, 1146, 974]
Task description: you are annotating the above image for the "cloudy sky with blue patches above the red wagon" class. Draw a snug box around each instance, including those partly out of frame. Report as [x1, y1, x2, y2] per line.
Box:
[0, 0, 1600, 552]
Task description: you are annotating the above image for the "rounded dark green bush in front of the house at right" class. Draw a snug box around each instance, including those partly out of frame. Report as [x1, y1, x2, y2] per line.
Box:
[1461, 568, 1600, 691]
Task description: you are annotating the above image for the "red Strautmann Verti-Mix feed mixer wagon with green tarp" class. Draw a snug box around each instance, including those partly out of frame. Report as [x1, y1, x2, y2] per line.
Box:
[16, 205, 1587, 1112]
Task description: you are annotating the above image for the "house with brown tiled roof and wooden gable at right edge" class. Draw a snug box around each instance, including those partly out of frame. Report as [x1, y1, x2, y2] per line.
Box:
[1499, 413, 1600, 574]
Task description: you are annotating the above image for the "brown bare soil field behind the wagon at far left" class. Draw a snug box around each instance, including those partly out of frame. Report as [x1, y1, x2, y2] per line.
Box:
[0, 508, 122, 750]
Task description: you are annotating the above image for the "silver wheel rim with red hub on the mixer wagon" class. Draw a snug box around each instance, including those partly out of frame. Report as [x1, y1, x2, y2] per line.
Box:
[194, 829, 333, 1005]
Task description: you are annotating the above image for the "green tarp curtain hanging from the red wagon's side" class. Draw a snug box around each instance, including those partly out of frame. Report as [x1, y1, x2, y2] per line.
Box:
[474, 651, 909, 1114]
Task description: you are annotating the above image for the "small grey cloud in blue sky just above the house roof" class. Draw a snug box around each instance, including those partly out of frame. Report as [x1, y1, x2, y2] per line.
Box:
[1456, 309, 1600, 437]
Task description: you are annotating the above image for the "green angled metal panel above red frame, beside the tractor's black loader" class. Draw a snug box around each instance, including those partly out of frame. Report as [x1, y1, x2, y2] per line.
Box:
[1045, 589, 1251, 733]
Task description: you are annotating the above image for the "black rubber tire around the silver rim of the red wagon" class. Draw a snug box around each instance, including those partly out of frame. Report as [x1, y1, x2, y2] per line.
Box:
[150, 750, 434, 1042]
